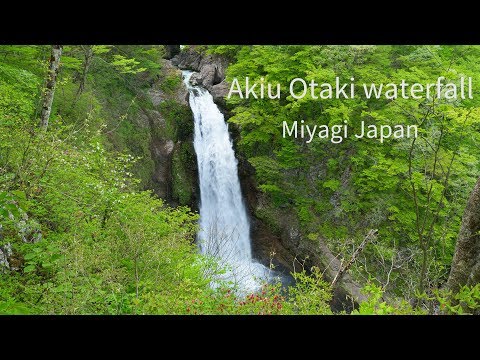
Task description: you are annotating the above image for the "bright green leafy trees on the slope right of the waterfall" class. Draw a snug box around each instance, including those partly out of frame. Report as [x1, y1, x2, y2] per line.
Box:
[217, 46, 480, 310]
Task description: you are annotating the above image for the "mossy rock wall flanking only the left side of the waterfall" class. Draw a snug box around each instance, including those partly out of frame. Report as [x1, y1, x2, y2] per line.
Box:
[138, 60, 198, 209]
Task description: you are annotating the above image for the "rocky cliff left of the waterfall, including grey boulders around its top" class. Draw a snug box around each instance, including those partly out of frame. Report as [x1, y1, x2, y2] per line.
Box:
[129, 45, 228, 210]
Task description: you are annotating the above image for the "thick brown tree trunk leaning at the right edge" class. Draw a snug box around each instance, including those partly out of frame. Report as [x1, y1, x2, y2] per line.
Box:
[447, 178, 480, 293]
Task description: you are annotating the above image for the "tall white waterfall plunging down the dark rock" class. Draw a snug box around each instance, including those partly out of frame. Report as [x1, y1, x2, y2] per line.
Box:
[183, 71, 269, 291]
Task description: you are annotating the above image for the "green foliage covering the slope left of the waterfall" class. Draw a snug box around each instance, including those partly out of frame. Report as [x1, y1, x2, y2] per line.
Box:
[0, 46, 205, 314]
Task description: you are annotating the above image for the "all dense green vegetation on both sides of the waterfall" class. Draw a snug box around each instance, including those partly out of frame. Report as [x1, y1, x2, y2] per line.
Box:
[0, 46, 480, 314]
